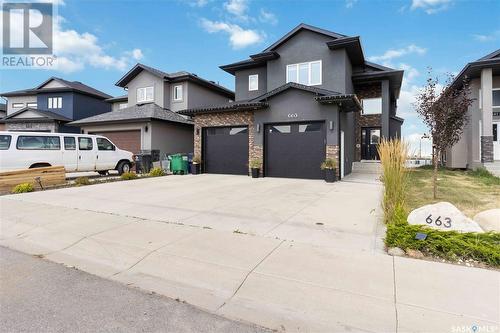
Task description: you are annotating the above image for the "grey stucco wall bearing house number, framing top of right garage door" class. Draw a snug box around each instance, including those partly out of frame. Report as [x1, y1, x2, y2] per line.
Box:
[254, 89, 339, 145]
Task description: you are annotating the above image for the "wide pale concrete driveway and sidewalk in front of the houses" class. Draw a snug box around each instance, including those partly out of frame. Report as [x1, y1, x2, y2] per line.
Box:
[0, 175, 500, 332]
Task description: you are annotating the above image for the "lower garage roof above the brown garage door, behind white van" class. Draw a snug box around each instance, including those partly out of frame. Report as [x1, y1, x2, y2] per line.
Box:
[69, 103, 193, 126]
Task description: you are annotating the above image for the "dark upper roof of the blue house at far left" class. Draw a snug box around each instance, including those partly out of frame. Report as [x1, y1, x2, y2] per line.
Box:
[1, 77, 112, 99]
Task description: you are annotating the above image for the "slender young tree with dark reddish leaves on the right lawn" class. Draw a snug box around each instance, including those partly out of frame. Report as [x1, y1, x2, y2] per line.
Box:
[414, 69, 473, 199]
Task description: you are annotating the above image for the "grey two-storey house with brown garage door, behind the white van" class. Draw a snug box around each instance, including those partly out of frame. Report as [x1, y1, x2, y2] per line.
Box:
[71, 64, 234, 154]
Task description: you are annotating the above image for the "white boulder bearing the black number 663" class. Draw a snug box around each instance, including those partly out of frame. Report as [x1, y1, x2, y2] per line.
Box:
[408, 202, 484, 232]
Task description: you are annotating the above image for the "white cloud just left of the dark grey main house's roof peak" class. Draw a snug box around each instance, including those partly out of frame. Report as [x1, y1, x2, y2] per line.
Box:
[200, 18, 265, 49]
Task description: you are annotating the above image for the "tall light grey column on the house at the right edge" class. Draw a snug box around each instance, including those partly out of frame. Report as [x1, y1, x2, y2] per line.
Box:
[480, 68, 493, 163]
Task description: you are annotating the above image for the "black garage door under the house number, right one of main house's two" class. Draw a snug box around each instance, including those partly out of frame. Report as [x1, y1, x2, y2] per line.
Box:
[264, 122, 326, 179]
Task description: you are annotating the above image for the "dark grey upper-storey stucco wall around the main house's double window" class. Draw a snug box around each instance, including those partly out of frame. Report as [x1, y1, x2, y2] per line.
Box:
[266, 30, 352, 94]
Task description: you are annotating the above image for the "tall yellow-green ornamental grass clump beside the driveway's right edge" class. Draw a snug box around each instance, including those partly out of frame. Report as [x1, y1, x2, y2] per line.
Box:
[377, 139, 408, 223]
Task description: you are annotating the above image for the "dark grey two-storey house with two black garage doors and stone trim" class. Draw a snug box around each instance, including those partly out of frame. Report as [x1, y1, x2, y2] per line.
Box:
[181, 24, 403, 179]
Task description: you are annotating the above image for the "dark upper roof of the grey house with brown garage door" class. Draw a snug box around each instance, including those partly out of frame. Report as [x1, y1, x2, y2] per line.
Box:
[115, 63, 234, 99]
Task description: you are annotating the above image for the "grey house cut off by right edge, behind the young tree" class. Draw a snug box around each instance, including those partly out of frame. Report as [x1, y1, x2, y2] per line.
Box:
[446, 49, 500, 175]
